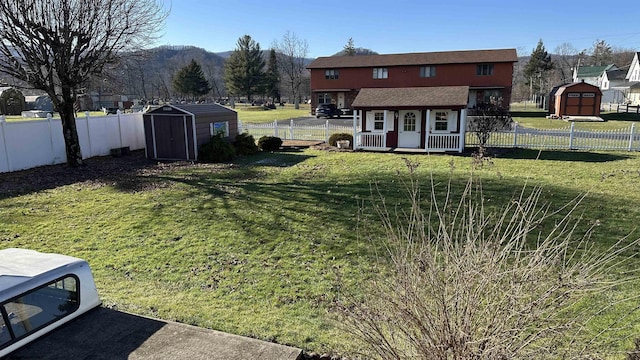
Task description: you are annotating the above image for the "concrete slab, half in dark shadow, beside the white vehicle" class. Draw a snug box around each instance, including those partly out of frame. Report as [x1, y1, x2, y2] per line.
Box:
[5, 307, 302, 360]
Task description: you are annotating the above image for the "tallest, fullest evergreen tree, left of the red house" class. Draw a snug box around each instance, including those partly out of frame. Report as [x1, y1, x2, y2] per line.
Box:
[224, 35, 265, 101]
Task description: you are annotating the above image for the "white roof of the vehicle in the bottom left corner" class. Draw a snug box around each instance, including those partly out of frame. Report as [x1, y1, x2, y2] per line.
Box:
[0, 248, 85, 301]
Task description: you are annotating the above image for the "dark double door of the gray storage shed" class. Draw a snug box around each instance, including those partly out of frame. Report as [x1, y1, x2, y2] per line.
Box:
[154, 116, 188, 159]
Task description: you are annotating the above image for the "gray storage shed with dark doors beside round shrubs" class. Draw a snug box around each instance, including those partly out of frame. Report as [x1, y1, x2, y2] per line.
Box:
[144, 104, 238, 160]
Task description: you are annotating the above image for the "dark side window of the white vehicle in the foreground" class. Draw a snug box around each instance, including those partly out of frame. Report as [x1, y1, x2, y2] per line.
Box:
[0, 276, 78, 343]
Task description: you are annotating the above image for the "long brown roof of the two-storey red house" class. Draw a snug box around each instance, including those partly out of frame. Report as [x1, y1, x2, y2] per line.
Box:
[307, 49, 518, 69]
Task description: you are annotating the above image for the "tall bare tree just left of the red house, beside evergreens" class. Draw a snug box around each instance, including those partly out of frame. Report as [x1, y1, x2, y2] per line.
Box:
[272, 31, 309, 109]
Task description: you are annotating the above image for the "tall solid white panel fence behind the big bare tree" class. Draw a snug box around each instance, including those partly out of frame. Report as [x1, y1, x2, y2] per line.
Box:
[0, 113, 145, 172]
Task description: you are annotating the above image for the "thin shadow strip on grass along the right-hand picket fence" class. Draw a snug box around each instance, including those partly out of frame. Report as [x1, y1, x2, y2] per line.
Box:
[494, 149, 631, 163]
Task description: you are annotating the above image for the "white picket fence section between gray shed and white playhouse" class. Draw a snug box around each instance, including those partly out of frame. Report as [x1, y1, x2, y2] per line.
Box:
[238, 120, 353, 142]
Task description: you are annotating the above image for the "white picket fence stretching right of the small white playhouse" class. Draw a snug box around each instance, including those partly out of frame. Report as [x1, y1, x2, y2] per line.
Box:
[466, 123, 640, 151]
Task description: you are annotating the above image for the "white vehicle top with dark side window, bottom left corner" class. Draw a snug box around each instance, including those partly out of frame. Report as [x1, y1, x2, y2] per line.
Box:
[0, 249, 100, 357]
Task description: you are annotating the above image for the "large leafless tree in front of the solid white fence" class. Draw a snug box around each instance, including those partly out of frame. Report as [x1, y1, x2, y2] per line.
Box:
[0, 0, 167, 166]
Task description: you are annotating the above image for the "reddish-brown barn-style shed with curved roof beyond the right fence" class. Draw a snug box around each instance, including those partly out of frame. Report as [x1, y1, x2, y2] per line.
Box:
[549, 82, 602, 118]
